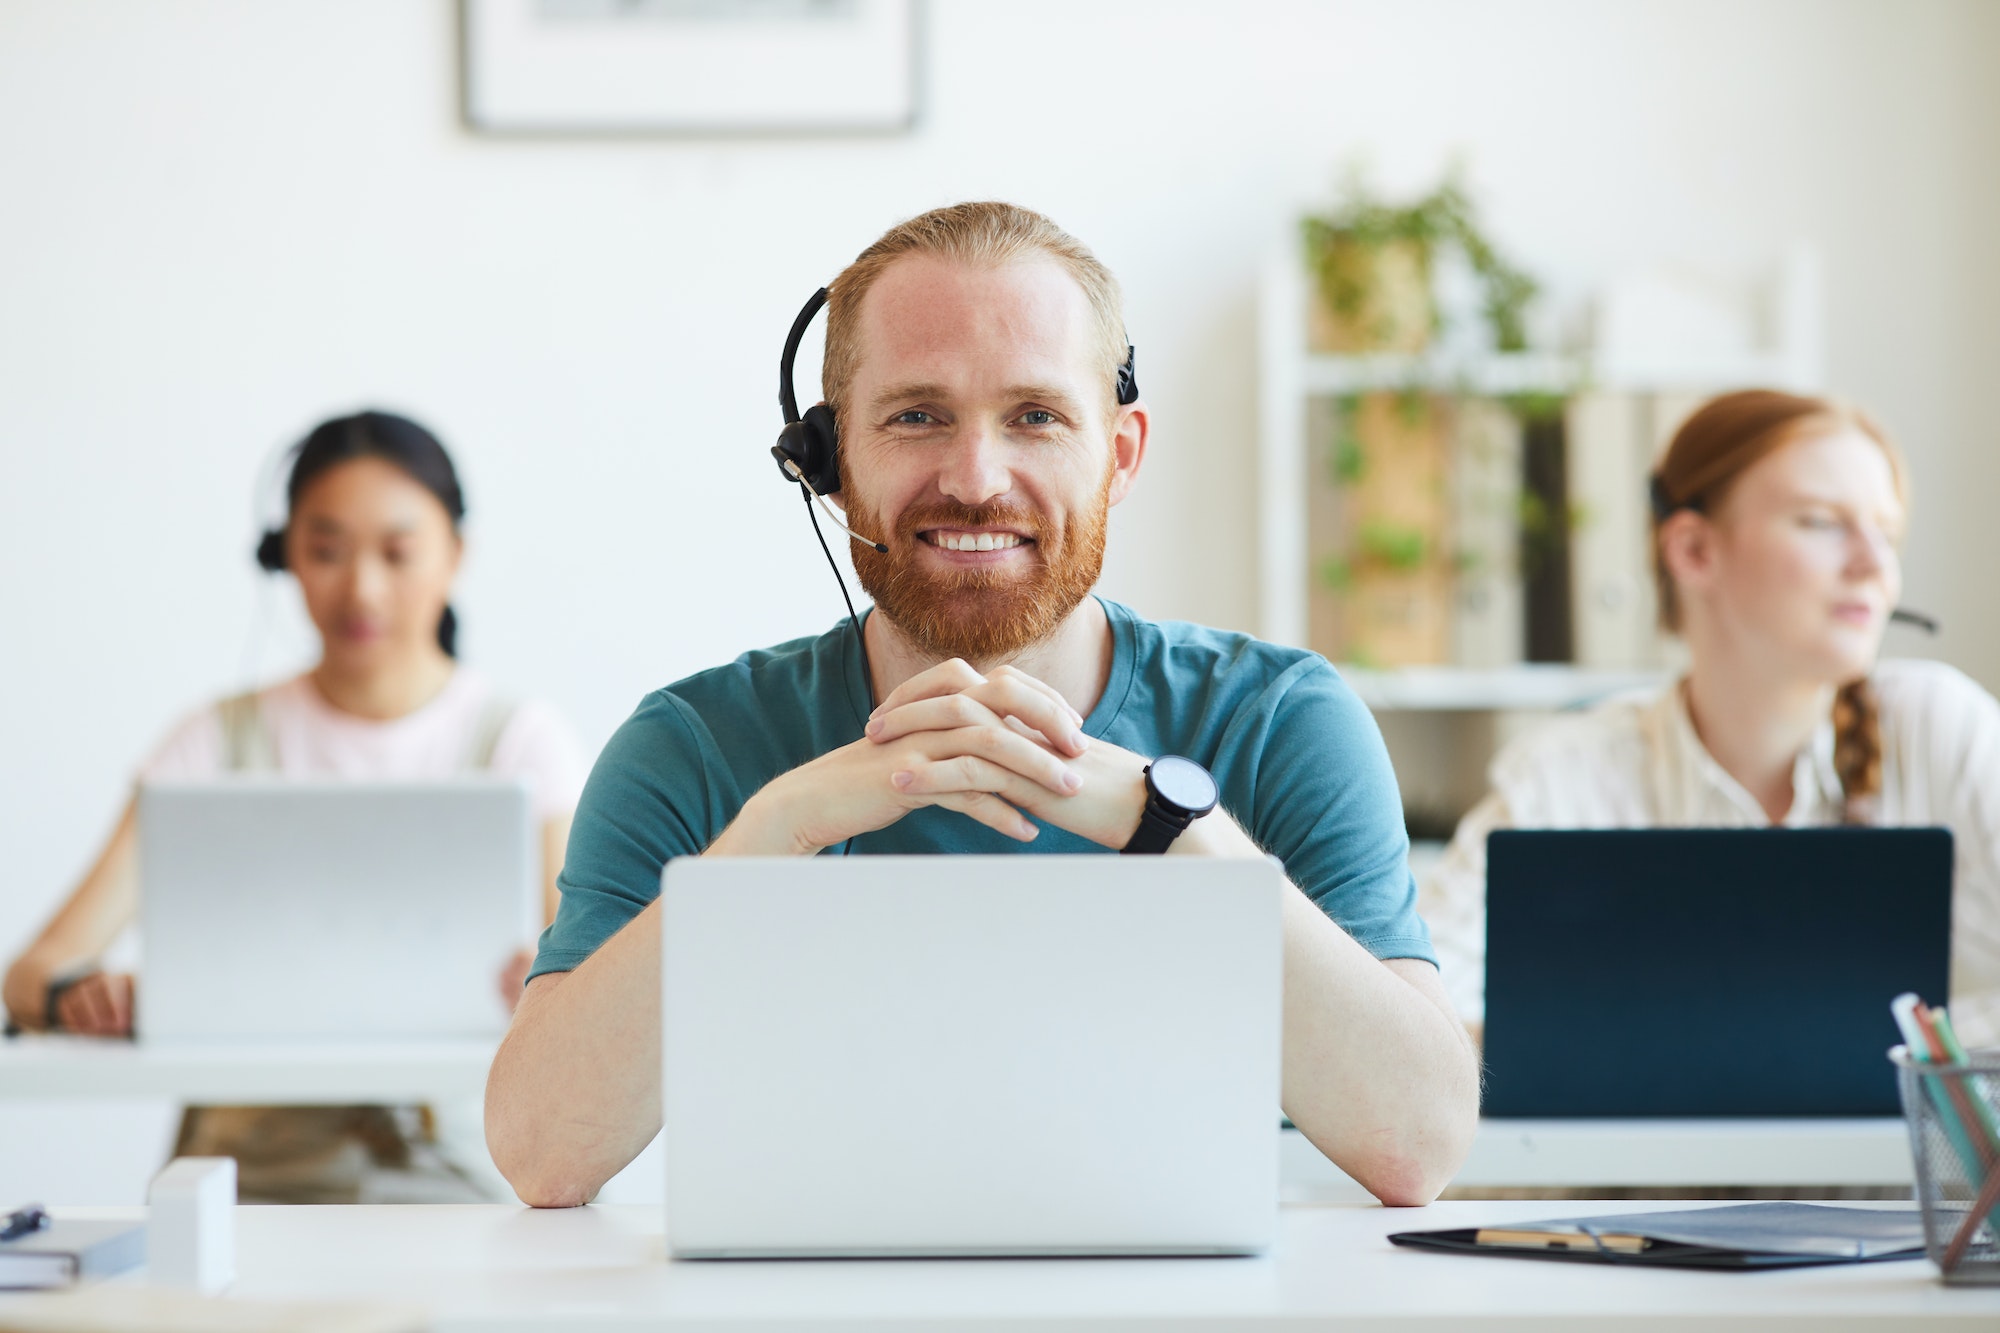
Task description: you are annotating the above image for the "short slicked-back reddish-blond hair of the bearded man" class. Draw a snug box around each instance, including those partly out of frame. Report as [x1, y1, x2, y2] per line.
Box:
[820, 202, 1126, 428]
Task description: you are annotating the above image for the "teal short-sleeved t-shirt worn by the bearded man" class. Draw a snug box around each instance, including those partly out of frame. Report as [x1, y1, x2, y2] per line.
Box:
[530, 600, 1436, 977]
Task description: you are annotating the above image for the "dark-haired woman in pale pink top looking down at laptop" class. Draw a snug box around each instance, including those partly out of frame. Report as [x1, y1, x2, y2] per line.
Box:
[4, 412, 582, 1197]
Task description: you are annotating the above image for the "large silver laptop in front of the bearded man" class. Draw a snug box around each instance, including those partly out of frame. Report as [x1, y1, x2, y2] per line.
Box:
[660, 857, 1284, 1257]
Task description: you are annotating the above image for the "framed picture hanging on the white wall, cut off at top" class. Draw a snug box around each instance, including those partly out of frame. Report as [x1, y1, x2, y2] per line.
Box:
[458, 0, 922, 136]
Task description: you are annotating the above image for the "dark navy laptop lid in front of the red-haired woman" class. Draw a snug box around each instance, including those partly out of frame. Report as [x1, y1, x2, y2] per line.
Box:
[1484, 829, 1952, 1117]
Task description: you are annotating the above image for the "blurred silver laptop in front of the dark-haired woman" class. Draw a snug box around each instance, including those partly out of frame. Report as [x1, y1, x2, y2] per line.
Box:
[138, 779, 540, 1041]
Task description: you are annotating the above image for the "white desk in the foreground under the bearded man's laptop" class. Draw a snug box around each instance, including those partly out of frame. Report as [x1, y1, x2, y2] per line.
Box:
[0, 1203, 2000, 1333]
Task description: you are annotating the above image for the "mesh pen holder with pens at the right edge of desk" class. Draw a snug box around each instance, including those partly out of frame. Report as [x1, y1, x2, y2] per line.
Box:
[1888, 1047, 2000, 1283]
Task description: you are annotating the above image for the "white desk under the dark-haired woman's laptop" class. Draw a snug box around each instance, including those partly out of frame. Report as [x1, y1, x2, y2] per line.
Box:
[0, 1035, 498, 1105]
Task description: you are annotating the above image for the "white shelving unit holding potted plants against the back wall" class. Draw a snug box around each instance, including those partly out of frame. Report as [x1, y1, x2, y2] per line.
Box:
[1256, 246, 1822, 821]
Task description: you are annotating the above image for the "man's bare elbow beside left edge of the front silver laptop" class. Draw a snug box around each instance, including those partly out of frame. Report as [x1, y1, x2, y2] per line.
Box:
[486, 903, 660, 1207]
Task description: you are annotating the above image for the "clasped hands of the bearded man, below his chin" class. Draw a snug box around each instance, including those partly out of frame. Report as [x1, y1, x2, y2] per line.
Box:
[736, 658, 1148, 855]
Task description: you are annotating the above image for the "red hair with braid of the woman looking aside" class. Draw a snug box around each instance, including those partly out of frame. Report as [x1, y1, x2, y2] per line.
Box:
[1652, 388, 1910, 821]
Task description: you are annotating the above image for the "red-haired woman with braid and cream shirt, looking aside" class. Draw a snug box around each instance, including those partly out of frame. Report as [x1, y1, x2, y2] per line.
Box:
[1424, 390, 2000, 1045]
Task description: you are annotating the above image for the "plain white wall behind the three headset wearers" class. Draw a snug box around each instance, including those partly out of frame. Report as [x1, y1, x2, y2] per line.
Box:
[0, 0, 2000, 955]
